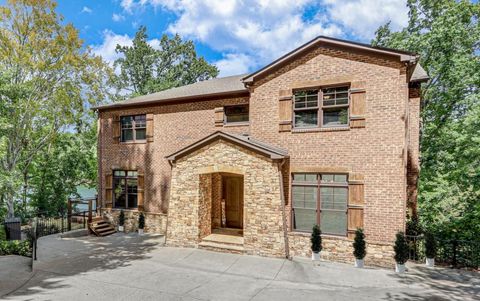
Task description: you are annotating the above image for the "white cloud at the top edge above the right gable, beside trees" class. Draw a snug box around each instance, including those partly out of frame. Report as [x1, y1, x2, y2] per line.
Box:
[324, 0, 408, 39]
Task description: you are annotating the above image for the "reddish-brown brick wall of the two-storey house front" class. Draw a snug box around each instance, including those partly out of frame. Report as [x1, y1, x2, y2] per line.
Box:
[96, 47, 418, 241]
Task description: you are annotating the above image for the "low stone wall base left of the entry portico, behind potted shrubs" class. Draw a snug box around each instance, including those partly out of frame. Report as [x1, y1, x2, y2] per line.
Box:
[101, 208, 167, 234]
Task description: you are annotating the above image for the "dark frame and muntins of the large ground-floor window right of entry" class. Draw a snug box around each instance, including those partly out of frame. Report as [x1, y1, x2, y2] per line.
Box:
[290, 172, 350, 237]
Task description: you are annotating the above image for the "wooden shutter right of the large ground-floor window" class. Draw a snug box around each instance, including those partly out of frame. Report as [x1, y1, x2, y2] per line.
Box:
[348, 173, 365, 238]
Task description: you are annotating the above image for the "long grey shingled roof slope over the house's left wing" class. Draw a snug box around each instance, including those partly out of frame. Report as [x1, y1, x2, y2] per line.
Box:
[94, 74, 248, 109]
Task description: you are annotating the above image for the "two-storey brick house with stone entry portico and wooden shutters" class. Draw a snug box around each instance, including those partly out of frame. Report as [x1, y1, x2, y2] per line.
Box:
[95, 37, 428, 265]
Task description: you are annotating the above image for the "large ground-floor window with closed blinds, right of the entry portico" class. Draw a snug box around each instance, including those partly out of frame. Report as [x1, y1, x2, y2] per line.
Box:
[292, 174, 348, 236]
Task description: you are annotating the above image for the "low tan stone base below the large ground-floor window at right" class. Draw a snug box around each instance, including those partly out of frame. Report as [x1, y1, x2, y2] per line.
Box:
[288, 232, 395, 267]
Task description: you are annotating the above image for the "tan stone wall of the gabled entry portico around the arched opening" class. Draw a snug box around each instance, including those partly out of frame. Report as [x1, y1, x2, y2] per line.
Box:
[167, 140, 285, 257]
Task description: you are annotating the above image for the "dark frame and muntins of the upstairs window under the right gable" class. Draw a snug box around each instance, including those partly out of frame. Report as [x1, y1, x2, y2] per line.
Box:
[292, 84, 351, 130]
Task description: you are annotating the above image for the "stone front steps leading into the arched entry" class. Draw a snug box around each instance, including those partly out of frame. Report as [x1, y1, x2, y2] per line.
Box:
[198, 233, 245, 254]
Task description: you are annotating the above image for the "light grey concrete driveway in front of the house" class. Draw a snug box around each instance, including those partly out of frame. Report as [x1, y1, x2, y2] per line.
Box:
[0, 233, 480, 301]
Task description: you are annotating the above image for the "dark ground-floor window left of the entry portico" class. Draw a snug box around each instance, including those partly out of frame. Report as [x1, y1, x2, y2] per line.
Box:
[113, 170, 138, 209]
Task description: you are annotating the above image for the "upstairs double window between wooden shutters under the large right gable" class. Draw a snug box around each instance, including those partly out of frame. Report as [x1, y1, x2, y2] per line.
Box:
[294, 86, 349, 128]
